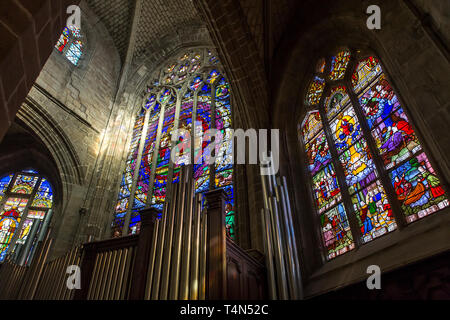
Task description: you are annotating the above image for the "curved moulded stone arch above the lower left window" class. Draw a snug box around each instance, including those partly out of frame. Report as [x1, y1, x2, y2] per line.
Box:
[13, 97, 86, 254]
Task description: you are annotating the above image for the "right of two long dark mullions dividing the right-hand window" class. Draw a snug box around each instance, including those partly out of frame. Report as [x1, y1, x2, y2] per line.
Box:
[346, 63, 406, 229]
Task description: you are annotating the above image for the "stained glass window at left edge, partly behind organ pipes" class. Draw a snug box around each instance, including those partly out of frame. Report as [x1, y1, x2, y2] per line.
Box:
[0, 170, 53, 264]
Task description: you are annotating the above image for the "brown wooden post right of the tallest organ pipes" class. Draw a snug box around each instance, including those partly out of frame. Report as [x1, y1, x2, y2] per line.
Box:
[206, 189, 227, 300]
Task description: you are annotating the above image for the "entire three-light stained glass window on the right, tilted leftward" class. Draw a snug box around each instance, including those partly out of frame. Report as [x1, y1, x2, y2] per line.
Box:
[299, 50, 449, 259]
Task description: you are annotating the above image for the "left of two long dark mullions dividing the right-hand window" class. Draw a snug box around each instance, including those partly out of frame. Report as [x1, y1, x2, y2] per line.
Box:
[318, 95, 362, 248]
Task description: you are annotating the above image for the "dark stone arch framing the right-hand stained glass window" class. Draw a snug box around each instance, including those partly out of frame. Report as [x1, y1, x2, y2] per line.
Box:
[272, 1, 450, 290]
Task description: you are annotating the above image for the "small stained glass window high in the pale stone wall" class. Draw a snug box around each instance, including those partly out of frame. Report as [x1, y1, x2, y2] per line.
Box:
[55, 26, 84, 66]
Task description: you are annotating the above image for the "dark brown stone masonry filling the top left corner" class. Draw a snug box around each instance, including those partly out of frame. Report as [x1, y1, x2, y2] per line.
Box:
[0, 0, 80, 141]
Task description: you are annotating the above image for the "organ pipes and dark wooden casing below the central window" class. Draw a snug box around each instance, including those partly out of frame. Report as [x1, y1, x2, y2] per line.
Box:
[0, 170, 267, 300]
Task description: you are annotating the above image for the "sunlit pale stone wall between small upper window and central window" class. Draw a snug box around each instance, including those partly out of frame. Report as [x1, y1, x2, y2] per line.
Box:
[18, 2, 120, 255]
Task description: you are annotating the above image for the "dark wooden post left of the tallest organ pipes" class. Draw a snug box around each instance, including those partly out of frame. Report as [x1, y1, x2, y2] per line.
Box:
[130, 208, 158, 300]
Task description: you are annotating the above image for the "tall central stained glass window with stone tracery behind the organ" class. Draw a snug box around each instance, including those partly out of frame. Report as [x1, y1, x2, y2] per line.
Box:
[112, 49, 235, 238]
